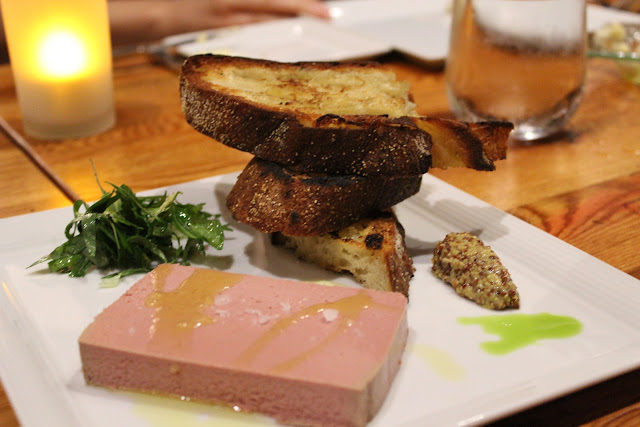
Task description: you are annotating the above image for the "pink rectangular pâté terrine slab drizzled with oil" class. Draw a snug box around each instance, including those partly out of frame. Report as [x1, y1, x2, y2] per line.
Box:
[79, 264, 407, 426]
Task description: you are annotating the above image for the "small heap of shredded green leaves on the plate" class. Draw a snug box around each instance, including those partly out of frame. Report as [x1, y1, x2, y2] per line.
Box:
[29, 177, 231, 287]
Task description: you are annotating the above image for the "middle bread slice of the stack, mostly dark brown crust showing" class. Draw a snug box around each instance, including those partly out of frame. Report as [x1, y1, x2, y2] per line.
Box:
[227, 157, 422, 236]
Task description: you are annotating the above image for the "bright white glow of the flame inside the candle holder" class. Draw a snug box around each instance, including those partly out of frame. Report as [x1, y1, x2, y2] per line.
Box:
[39, 31, 87, 77]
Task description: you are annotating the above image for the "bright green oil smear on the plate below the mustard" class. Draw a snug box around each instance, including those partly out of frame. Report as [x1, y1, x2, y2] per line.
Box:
[458, 313, 582, 355]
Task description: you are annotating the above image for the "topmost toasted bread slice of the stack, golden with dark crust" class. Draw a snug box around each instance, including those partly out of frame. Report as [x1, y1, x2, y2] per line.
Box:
[180, 55, 431, 175]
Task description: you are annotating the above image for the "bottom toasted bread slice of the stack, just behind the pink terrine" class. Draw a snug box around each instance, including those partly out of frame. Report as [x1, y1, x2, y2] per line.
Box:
[272, 212, 415, 298]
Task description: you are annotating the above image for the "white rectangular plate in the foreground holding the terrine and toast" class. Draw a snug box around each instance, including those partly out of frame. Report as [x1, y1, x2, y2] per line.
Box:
[0, 174, 640, 427]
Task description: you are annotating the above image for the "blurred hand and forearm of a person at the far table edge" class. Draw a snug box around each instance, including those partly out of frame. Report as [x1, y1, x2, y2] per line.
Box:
[109, 0, 329, 44]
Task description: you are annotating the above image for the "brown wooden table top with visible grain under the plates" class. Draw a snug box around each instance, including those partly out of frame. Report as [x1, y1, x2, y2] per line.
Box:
[0, 55, 640, 427]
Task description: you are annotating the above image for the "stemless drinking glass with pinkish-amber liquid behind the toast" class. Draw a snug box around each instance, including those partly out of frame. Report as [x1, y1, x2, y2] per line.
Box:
[445, 0, 587, 141]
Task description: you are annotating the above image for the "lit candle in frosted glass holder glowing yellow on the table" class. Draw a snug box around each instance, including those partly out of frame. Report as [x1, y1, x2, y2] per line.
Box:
[0, 0, 115, 139]
